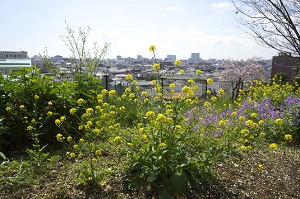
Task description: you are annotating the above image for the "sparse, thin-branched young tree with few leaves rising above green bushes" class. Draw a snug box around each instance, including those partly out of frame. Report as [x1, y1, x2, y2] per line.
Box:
[61, 21, 110, 75]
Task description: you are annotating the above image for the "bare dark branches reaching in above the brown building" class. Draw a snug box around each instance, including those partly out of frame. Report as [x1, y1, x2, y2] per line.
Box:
[231, 0, 300, 56]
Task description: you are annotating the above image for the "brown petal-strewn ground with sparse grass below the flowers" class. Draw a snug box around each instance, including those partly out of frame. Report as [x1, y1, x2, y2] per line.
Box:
[0, 147, 300, 198]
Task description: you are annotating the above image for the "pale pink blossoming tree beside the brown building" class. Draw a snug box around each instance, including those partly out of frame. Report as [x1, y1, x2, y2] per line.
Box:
[221, 58, 266, 100]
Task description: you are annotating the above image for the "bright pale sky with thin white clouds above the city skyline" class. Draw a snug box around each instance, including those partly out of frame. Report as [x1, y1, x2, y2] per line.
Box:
[0, 0, 276, 60]
